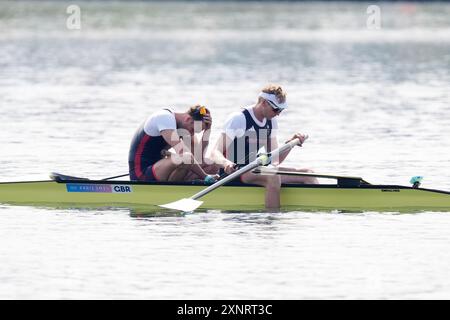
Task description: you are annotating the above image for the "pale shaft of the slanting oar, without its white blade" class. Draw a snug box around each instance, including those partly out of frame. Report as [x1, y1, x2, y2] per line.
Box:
[191, 138, 300, 200]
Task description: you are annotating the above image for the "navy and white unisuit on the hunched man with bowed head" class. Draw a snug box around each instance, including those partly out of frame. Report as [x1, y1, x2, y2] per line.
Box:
[128, 109, 177, 181]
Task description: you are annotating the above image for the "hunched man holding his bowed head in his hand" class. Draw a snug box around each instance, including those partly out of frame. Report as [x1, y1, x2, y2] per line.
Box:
[128, 105, 217, 184]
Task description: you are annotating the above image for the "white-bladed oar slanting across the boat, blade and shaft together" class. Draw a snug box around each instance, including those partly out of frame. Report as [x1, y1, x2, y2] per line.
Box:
[159, 139, 300, 212]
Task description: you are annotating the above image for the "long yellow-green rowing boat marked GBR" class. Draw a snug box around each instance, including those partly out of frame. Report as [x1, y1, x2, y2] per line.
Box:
[0, 169, 450, 212]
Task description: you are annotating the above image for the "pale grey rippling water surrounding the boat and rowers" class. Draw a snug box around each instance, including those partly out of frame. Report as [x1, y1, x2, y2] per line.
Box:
[0, 1, 450, 299]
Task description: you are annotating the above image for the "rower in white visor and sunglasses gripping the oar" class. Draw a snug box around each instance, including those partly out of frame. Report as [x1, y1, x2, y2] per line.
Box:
[211, 85, 318, 209]
